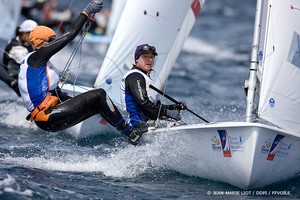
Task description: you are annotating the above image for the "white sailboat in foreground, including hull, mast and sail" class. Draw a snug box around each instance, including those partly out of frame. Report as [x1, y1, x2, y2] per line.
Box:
[144, 0, 300, 189]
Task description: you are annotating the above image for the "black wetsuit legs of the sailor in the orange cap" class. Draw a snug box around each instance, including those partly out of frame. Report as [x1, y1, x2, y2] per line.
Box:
[35, 89, 125, 132]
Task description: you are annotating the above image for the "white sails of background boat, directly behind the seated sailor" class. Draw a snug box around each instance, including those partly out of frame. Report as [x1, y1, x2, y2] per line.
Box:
[94, 0, 204, 105]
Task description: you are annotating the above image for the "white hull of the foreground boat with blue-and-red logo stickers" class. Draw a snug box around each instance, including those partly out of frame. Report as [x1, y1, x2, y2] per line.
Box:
[144, 122, 300, 189]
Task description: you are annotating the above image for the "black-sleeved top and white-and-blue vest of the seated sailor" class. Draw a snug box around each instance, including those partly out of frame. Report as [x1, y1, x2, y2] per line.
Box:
[121, 66, 166, 126]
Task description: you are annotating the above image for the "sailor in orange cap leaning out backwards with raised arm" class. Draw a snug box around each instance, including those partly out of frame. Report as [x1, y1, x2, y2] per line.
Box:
[19, 0, 146, 145]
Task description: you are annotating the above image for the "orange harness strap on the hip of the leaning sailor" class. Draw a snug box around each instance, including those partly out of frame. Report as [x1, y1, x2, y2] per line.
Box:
[26, 94, 58, 122]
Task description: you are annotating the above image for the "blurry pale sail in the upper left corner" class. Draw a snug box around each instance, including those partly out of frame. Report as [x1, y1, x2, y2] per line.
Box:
[0, 0, 21, 41]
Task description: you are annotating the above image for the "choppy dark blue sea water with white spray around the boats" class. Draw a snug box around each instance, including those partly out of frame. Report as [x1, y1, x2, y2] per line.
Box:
[0, 0, 300, 199]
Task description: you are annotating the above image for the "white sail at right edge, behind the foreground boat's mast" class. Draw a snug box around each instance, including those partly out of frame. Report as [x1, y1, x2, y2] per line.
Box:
[258, 0, 300, 133]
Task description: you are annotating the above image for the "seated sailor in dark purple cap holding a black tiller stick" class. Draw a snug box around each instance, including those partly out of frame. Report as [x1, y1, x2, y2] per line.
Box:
[121, 44, 186, 127]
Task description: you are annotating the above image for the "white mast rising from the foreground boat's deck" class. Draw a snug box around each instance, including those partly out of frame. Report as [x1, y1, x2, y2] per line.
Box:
[246, 0, 263, 122]
